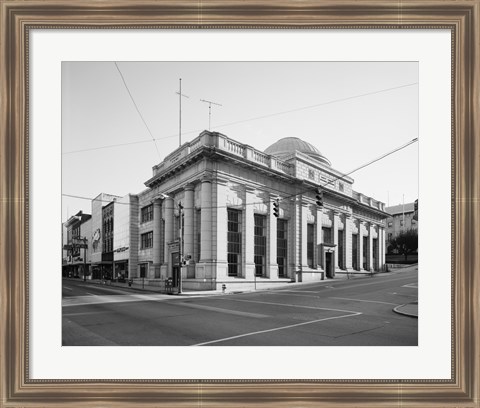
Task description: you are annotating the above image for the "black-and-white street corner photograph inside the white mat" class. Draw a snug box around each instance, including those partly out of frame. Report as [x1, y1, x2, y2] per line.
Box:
[62, 61, 419, 347]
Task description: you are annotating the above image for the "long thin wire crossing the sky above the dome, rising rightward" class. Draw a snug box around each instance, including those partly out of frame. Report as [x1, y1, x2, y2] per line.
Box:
[62, 82, 418, 154]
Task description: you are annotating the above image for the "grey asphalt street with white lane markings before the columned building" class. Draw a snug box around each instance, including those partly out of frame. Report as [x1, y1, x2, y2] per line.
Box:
[62, 267, 418, 346]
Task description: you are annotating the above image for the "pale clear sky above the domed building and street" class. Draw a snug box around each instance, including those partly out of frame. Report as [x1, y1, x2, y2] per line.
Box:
[62, 61, 419, 221]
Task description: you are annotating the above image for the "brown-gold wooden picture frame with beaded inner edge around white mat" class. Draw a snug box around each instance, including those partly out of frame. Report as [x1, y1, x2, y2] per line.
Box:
[0, 0, 480, 408]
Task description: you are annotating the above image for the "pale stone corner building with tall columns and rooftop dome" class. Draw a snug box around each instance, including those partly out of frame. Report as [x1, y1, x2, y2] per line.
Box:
[119, 131, 388, 290]
